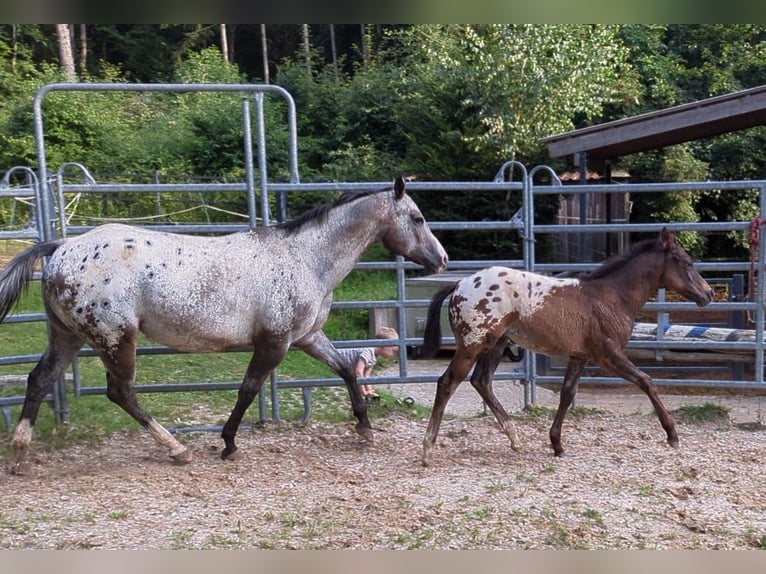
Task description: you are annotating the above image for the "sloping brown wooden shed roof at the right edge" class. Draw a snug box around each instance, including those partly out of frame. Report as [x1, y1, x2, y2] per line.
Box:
[541, 85, 766, 160]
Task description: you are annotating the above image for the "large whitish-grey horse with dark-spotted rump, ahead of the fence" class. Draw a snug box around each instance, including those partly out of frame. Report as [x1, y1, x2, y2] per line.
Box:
[0, 178, 447, 471]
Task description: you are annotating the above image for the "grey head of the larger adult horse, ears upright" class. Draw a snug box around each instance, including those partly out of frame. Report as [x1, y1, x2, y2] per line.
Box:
[381, 177, 449, 273]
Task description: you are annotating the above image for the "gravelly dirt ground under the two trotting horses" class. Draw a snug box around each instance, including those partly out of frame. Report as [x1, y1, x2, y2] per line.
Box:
[0, 358, 766, 549]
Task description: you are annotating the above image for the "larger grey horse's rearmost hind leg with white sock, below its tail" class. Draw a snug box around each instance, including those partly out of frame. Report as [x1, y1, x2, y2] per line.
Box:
[10, 320, 82, 474]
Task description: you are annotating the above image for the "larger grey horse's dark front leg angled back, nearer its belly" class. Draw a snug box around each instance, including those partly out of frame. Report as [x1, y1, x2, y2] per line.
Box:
[221, 342, 287, 460]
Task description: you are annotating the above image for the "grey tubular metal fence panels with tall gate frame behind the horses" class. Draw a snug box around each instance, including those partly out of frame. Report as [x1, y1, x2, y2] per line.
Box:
[0, 84, 766, 430]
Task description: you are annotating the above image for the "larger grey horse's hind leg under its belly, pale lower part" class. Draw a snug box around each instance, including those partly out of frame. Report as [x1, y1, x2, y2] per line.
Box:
[99, 331, 191, 464]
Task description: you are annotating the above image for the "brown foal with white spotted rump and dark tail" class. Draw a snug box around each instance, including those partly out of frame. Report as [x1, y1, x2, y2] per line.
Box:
[422, 229, 713, 466]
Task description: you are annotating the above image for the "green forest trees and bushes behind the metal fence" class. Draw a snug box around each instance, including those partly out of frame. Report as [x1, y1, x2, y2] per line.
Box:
[0, 24, 766, 258]
